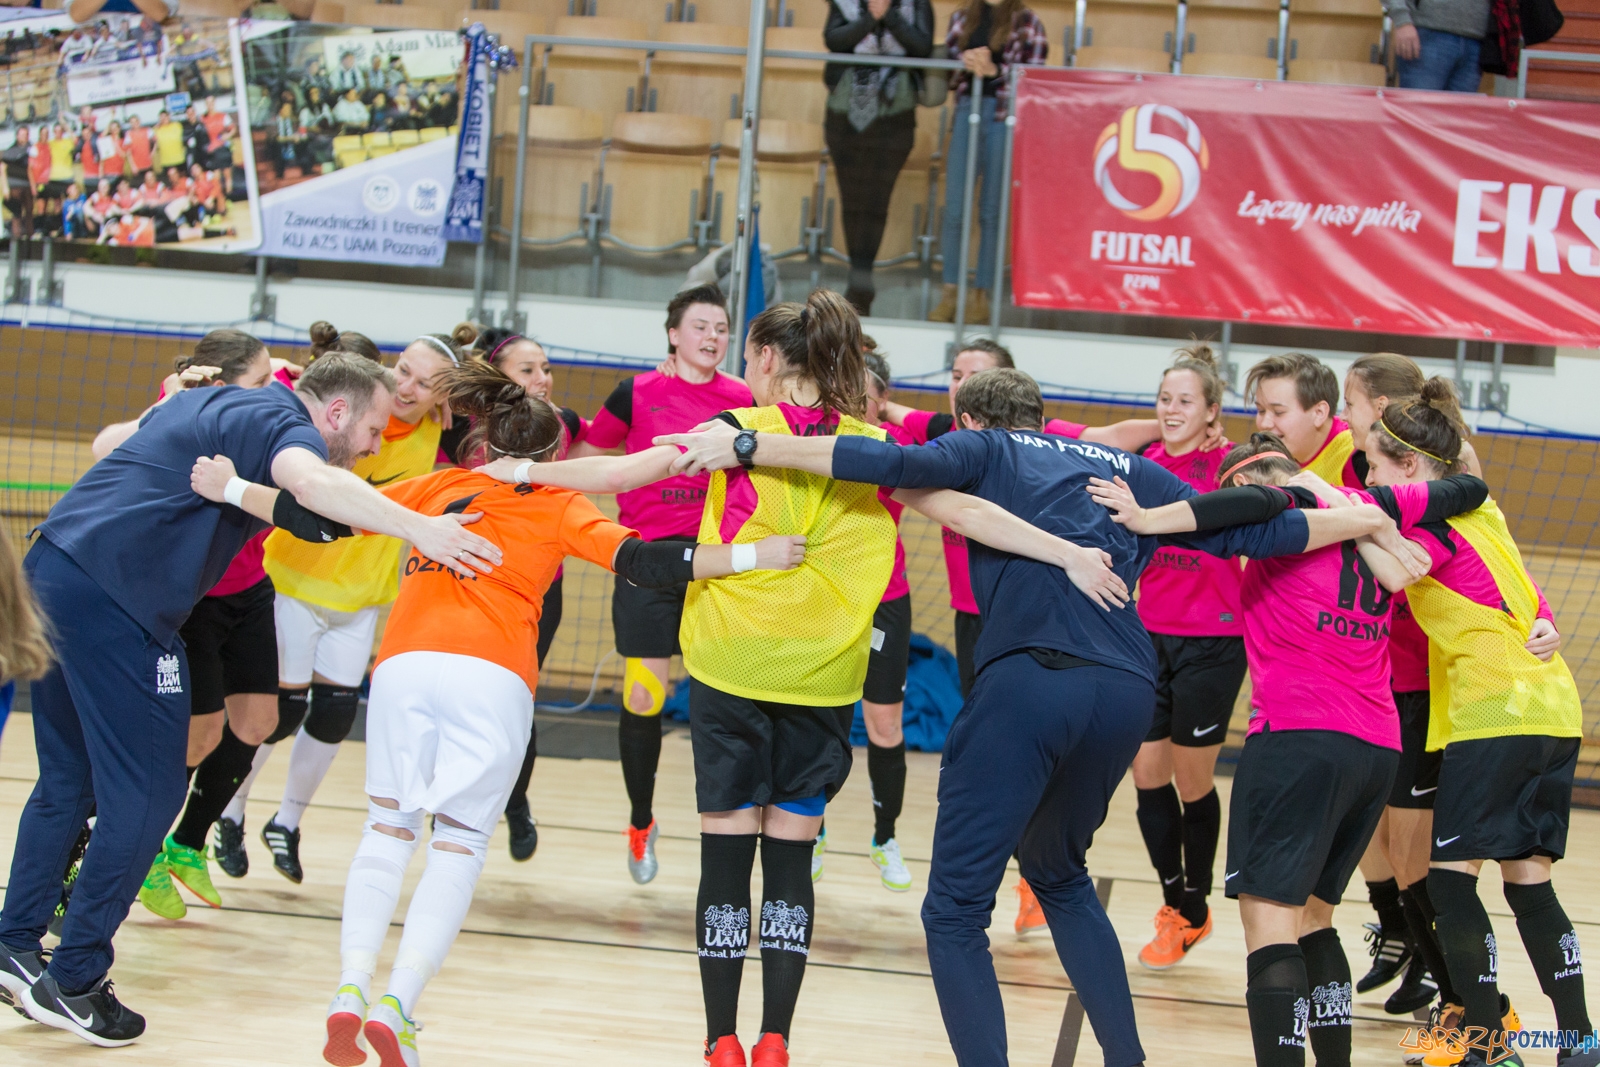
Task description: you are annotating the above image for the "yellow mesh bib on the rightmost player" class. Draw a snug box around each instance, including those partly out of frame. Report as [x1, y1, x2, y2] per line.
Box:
[1406, 501, 1584, 752]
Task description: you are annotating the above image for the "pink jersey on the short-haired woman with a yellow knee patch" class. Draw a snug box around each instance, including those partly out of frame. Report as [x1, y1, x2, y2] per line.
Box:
[587, 371, 754, 541]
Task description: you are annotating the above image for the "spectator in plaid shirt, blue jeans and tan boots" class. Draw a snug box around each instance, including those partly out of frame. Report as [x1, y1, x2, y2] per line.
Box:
[928, 0, 1050, 322]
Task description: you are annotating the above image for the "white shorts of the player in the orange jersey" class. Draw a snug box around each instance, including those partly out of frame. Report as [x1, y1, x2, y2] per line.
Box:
[366, 653, 533, 833]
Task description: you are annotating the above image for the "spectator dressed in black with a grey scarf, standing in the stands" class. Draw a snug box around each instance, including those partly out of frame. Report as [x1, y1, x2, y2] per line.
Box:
[822, 0, 933, 315]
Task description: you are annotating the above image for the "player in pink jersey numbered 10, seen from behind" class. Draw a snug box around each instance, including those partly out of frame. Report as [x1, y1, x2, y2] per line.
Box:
[1090, 434, 1488, 1067]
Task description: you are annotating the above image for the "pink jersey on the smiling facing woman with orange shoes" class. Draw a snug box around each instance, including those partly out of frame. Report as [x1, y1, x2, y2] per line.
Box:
[1139, 442, 1245, 637]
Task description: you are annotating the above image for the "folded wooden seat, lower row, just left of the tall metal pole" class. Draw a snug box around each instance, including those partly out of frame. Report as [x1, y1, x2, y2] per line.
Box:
[605, 112, 715, 248]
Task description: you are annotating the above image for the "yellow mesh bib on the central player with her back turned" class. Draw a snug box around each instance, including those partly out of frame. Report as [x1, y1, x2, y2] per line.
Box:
[678, 408, 894, 707]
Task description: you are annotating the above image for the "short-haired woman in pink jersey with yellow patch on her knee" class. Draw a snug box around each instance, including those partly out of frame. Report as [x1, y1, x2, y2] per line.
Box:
[574, 285, 750, 885]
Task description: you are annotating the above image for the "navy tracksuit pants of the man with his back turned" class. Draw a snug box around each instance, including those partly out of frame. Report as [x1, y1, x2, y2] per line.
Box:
[922, 651, 1155, 1067]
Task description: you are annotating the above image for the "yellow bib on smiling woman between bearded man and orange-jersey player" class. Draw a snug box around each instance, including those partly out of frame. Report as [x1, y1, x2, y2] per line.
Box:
[262, 416, 442, 611]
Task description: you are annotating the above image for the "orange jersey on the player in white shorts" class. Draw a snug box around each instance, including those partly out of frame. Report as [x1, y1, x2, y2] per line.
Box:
[374, 469, 638, 693]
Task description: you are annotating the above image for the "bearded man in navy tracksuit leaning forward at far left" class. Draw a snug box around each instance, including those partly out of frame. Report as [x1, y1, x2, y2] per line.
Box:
[0, 349, 499, 1046]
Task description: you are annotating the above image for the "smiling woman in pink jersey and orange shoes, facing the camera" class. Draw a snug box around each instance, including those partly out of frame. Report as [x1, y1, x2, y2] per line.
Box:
[1133, 344, 1245, 971]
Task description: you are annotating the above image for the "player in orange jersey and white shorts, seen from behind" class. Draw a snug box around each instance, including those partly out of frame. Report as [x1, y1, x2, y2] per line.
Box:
[195, 362, 805, 1067]
